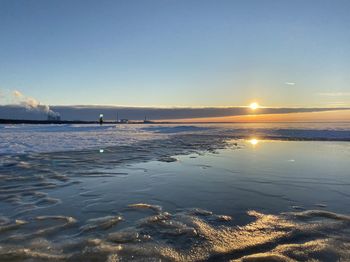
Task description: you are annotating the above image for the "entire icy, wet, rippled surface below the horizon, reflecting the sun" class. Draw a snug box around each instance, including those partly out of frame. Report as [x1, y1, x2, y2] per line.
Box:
[0, 123, 350, 261]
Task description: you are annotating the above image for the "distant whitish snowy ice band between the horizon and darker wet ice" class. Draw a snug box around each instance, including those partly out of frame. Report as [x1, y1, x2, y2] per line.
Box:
[0, 122, 350, 156]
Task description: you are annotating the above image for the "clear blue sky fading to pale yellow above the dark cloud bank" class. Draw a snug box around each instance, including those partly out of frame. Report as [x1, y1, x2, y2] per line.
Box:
[0, 0, 350, 107]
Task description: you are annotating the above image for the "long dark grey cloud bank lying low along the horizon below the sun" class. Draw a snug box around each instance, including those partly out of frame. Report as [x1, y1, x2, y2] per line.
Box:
[0, 105, 350, 121]
